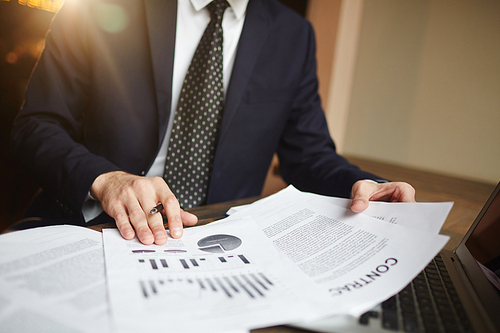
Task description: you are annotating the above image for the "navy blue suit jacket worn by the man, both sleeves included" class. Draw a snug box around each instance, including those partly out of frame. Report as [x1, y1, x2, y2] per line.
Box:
[13, 0, 375, 224]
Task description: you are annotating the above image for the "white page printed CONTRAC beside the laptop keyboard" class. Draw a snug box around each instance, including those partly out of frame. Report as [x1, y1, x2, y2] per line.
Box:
[231, 187, 451, 316]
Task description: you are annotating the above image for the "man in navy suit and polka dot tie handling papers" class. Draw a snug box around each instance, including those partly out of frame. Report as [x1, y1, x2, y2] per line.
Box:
[13, 0, 415, 244]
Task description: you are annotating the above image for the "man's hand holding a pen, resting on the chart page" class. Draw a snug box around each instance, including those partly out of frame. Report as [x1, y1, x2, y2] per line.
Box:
[91, 171, 198, 245]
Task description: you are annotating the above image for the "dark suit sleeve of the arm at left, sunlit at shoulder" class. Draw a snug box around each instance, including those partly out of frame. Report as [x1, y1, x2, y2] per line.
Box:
[12, 1, 118, 222]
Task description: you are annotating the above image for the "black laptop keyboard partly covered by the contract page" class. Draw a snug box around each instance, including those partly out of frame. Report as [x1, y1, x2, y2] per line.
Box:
[359, 255, 474, 333]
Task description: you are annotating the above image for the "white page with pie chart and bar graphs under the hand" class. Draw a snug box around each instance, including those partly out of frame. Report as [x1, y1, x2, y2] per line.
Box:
[103, 217, 331, 332]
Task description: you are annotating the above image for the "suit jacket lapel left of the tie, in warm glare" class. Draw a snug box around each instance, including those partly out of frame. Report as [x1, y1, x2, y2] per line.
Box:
[144, 0, 177, 146]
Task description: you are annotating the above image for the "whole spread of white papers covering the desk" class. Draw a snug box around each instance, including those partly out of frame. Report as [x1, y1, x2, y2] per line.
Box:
[0, 187, 451, 332]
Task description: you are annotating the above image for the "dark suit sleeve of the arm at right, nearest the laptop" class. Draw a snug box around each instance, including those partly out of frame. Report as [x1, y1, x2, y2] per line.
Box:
[278, 23, 380, 197]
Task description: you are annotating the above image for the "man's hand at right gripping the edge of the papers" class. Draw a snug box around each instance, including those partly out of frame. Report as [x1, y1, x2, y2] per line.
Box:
[351, 180, 415, 213]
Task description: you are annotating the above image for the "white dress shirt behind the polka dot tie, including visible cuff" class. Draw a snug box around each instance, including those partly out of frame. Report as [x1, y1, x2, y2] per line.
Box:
[82, 0, 248, 222]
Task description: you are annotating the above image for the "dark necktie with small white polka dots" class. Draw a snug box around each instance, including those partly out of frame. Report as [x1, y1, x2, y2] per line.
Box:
[164, 0, 229, 208]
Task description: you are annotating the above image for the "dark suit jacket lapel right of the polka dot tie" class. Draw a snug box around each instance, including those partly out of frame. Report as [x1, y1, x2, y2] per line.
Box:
[219, 0, 270, 140]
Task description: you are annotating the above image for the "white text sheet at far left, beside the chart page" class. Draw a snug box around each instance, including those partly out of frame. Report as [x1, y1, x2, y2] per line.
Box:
[0, 225, 110, 332]
